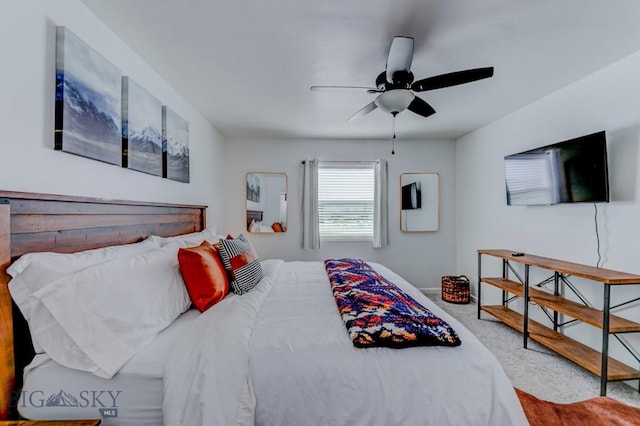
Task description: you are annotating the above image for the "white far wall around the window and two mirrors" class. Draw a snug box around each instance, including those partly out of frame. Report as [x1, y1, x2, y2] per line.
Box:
[224, 139, 456, 288]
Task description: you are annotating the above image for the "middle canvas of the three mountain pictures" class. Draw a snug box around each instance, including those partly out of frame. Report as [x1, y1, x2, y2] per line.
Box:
[122, 77, 163, 176]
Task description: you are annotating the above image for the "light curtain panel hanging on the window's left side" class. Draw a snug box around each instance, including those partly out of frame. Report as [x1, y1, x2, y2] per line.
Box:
[302, 158, 320, 250]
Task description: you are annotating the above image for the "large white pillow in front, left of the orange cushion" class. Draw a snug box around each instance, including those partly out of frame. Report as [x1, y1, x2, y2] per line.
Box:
[31, 244, 191, 378]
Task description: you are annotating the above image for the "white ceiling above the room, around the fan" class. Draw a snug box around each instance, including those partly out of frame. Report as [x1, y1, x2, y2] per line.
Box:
[82, 0, 640, 139]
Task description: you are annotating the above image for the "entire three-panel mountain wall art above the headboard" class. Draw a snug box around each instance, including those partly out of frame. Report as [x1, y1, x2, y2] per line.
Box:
[54, 27, 189, 183]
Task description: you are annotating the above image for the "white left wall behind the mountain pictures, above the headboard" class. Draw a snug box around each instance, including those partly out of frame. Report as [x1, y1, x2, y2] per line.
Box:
[0, 0, 224, 224]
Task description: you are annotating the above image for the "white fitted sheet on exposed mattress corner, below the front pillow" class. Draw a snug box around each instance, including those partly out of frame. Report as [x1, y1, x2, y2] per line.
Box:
[18, 309, 200, 426]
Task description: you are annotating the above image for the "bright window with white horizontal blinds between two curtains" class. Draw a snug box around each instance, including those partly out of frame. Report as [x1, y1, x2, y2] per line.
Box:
[318, 161, 375, 241]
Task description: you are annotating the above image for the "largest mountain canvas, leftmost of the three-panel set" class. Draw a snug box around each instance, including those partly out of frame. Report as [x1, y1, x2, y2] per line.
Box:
[54, 27, 122, 165]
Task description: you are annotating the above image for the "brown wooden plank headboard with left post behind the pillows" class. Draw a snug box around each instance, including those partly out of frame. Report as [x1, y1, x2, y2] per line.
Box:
[0, 191, 206, 419]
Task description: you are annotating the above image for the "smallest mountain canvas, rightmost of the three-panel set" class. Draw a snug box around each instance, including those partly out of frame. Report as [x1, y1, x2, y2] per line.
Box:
[162, 105, 189, 183]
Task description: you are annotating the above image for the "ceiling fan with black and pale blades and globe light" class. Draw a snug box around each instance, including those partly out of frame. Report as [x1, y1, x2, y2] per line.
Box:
[311, 36, 493, 121]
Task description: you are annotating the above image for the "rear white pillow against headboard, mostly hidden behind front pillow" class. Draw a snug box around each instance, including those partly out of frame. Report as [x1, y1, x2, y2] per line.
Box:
[7, 238, 160, 326]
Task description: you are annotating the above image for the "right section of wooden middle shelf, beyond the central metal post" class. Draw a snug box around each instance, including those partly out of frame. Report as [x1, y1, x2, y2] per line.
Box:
[529, 287, 640, 333]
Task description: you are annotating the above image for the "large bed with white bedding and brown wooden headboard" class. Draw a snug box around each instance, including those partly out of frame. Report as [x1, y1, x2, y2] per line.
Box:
[0, 191, 527, 425]
